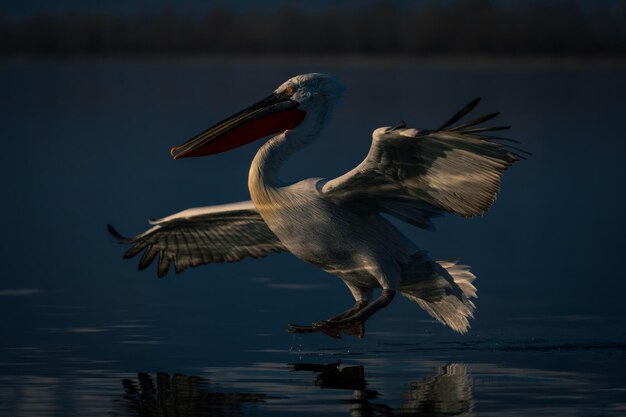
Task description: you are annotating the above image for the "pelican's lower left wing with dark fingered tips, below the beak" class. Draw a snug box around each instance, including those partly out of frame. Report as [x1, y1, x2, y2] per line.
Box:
[108, 201, 287, 277]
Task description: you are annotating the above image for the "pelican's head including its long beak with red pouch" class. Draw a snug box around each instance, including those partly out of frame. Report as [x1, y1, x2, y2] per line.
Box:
[170, 73, 344, 159]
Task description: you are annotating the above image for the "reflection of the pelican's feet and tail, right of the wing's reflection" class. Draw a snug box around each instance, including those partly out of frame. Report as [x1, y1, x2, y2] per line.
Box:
[292, 362, 474, 417]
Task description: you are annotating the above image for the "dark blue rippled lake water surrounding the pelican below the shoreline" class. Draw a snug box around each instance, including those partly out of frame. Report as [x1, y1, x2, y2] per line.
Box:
[0, 61, 626, 416]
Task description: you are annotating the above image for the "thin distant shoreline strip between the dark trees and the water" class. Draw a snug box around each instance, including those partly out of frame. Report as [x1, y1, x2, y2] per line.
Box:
[0, 54, 626, 70]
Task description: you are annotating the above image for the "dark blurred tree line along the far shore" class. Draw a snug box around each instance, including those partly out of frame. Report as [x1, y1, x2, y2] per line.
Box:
[0, 0, 626, 56]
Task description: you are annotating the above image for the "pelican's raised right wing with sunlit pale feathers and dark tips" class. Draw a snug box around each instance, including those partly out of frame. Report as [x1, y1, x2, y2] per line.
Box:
[321, 99, 526, 228]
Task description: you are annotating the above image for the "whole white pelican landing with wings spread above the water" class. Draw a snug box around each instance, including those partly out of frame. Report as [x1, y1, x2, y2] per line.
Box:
[108, 73, 523, 338]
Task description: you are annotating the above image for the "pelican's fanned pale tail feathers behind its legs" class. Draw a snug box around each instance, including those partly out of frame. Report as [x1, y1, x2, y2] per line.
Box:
[398, 252, 476, 334]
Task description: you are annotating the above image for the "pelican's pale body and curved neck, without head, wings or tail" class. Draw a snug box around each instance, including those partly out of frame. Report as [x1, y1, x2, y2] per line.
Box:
[248, 138, 416, 301]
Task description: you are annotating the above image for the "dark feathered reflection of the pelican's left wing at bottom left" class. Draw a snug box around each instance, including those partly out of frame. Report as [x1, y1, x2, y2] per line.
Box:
[116, 372, 266, 417]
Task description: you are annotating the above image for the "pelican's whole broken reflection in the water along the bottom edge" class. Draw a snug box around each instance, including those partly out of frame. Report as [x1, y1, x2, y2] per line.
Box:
[115, 362, 473, 417]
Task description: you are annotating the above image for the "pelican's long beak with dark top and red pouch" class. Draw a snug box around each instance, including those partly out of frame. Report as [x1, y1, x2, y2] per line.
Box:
[170, 93, 306, 159]
